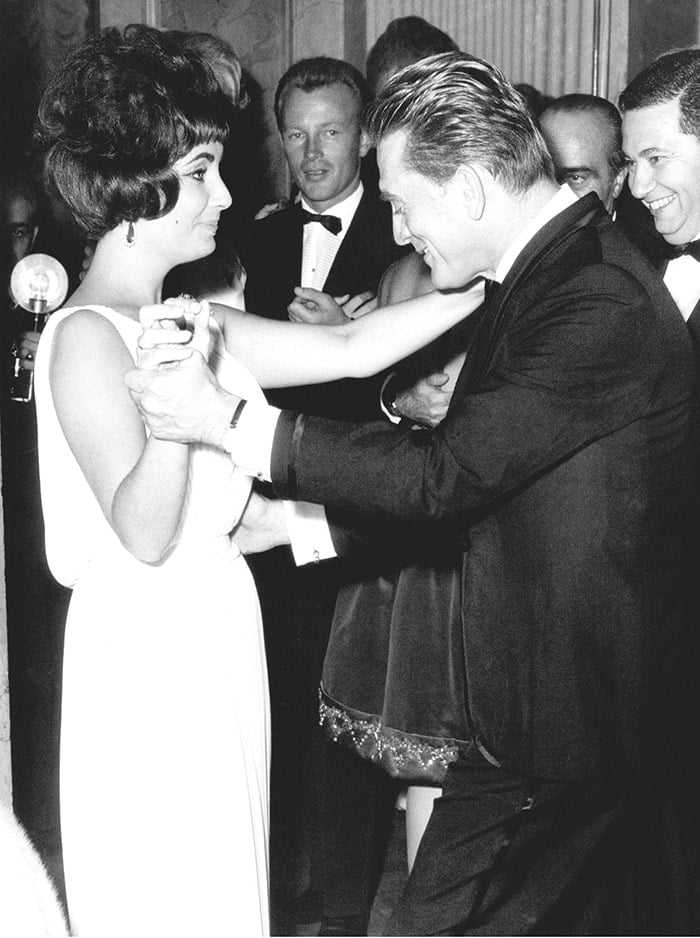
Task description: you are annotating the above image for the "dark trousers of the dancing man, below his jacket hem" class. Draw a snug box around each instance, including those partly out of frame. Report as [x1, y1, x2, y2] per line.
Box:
[384, 757, 700, 935]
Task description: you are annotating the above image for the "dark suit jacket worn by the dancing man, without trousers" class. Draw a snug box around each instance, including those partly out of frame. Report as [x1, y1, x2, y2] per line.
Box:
[272, 195, 694, 779]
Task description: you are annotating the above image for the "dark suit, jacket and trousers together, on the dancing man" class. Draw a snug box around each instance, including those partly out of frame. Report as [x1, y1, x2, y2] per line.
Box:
[266, 195, 695, 935]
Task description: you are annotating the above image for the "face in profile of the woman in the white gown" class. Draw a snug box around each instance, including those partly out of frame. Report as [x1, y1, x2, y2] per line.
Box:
[146, 143, 231, 267]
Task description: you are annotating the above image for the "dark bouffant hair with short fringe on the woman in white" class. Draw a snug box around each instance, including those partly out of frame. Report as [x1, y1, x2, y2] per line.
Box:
[39, 25, 230, 238]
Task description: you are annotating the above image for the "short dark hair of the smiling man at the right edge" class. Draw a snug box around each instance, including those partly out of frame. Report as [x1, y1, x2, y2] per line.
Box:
[618, 49, 700, 139]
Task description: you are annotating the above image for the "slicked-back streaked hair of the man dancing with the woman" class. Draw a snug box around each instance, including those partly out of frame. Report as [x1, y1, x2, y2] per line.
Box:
[366, 52, 554, 193]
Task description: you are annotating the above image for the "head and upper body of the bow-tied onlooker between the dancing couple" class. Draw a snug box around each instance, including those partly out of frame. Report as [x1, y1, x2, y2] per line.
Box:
[242, 57, 405, 419]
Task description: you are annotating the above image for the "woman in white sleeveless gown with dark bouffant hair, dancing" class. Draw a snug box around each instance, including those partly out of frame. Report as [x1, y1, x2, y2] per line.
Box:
[35, 27, 477, 938]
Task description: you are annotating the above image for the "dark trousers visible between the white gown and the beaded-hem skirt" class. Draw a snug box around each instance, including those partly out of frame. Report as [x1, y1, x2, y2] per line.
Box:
[249, 548, 397, 935]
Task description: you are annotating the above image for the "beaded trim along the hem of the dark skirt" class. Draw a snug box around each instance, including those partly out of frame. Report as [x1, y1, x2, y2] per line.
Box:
[319, 692, 471, 784]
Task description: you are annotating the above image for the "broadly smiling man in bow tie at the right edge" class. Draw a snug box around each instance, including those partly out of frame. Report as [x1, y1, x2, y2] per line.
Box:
[620, 49, 700, 353]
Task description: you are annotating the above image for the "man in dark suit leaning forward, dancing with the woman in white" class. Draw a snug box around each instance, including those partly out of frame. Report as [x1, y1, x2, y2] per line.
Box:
[128, 54, 697, 935]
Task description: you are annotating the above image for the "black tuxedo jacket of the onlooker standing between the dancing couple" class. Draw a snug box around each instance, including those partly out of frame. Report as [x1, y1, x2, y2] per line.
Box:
[242, 188, 405, 420]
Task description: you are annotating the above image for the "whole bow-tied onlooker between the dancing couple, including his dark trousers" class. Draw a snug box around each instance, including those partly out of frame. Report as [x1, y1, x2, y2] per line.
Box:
[241, 57, 402, 935]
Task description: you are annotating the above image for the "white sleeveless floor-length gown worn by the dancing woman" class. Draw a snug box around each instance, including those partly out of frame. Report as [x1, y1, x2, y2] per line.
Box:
[35, 307, 269, 938]
